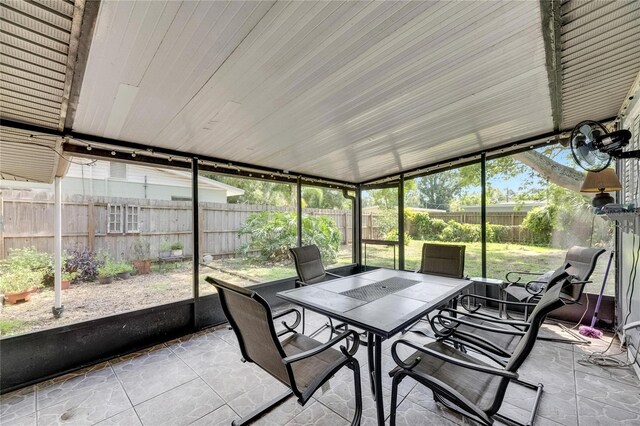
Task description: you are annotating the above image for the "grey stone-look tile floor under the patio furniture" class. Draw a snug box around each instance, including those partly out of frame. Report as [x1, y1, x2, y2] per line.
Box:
[0, 313, 640, 426]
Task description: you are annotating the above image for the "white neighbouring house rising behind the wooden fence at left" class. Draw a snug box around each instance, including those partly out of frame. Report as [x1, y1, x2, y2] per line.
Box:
[2, 159, 244, 203]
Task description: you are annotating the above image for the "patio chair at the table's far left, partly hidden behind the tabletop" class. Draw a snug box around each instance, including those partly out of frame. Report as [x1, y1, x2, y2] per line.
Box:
[289, 245, 346, 336]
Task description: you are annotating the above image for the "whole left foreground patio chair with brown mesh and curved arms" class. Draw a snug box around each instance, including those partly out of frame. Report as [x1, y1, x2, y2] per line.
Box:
[205, 277, 362, 426]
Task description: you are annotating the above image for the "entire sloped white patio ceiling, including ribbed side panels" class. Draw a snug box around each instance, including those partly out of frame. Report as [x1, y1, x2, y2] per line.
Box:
[0, 0, 640, 182]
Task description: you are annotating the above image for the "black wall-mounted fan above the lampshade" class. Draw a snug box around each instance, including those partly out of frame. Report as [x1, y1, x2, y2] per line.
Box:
[569, 120, 640, 172]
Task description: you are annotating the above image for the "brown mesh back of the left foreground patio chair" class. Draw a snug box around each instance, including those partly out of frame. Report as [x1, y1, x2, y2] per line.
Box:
[206, 277, 291, 385]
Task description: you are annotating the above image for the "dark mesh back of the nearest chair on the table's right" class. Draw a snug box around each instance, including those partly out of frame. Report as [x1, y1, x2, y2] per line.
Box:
[506, 272, 573, 371]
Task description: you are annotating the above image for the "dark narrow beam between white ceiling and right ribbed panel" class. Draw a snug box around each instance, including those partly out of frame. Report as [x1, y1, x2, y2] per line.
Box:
[540, 0, 562, 131]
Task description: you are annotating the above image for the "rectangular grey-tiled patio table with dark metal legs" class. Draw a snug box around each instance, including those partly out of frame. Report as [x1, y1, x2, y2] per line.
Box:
[278, 269, 472, 425]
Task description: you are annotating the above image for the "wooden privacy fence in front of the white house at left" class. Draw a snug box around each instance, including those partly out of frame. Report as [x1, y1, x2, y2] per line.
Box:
[0, 191, 353, 261]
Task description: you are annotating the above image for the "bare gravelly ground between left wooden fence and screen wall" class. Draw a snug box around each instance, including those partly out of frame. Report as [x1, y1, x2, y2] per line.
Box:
[0, 268, 246, 336]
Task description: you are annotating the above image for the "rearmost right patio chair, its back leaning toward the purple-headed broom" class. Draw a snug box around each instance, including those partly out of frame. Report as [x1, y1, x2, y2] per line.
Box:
[503, 246, 605, 320]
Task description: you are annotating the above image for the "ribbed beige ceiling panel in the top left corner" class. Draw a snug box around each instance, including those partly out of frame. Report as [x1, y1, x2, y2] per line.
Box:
[0, 0, 84, 130]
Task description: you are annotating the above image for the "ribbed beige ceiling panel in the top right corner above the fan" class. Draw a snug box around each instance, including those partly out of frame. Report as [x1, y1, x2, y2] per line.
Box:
[561, 0, 640, 127]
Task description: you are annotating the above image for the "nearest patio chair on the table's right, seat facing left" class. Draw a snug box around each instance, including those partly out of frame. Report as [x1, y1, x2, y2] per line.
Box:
[389, 272, 576, 426]
